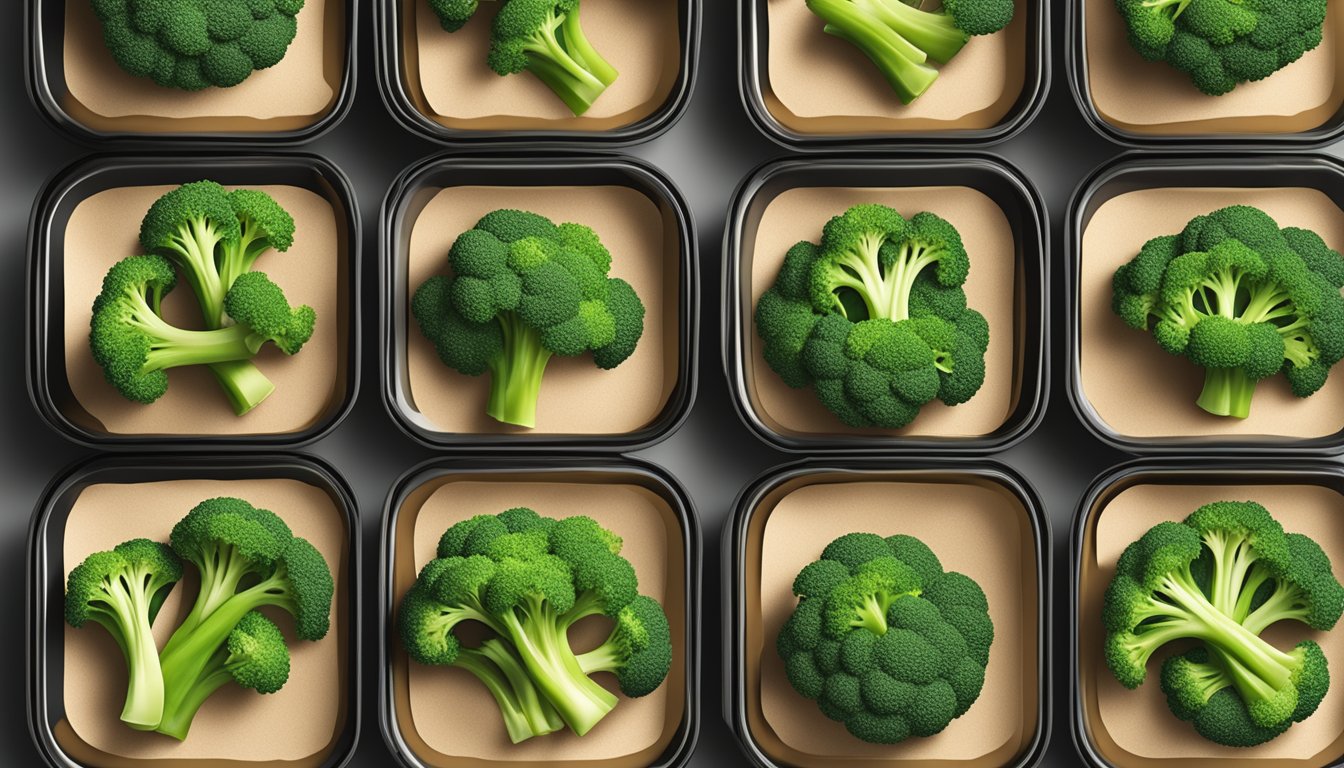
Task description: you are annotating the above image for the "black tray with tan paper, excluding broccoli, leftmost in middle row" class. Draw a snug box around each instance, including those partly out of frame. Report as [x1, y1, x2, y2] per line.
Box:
[27, 155, 360, 449]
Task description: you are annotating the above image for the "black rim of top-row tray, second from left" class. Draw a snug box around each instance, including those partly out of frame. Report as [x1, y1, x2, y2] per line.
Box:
[372, 0, 703, 151]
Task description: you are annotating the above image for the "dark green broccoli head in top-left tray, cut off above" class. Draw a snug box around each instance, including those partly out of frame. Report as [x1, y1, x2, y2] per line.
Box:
[93, 0, 304, 90]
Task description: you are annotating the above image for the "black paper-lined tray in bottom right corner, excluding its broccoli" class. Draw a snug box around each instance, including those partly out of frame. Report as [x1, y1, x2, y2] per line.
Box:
[1068, 459, 1344, 768]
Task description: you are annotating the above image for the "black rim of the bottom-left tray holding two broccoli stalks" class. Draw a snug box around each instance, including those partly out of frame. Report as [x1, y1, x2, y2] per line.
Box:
[24, 452, 364, 768]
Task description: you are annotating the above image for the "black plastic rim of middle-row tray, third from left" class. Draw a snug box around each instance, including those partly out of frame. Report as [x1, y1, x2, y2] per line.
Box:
[723, 155, 1050, 453]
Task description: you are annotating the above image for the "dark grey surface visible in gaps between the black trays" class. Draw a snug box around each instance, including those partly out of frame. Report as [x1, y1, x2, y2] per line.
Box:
[0, 0, 1236, 768]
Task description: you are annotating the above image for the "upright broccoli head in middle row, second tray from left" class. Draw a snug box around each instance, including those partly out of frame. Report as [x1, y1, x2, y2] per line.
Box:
[411, 210, 644, 428]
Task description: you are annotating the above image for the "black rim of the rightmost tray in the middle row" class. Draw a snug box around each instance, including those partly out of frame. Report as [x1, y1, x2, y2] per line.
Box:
[1063, 151, 1344, 456]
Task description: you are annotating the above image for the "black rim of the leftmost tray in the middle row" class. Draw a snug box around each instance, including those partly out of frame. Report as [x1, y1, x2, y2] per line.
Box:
[24, 151, 363, 451]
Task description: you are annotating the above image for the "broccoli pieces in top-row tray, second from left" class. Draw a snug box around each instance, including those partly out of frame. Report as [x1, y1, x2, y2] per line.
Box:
[429, 0, 618, 114]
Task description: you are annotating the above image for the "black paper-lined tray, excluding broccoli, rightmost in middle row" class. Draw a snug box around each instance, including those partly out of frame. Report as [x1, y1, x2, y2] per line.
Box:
[1064, 155, 1344, 453]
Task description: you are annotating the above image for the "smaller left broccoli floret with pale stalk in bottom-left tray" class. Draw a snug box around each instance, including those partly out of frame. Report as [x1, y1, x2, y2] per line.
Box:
[66, 539, 181, 730]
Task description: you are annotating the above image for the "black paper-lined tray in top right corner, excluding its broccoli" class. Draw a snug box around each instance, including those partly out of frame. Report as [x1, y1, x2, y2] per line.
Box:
[1064, 0, 1344, 149]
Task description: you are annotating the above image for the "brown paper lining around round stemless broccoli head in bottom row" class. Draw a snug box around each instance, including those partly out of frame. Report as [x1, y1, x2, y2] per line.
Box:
[745, 473, 1040, 768]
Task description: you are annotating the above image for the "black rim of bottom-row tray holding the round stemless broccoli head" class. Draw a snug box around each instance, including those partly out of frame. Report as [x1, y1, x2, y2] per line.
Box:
[720, 459, 1052, 768]
